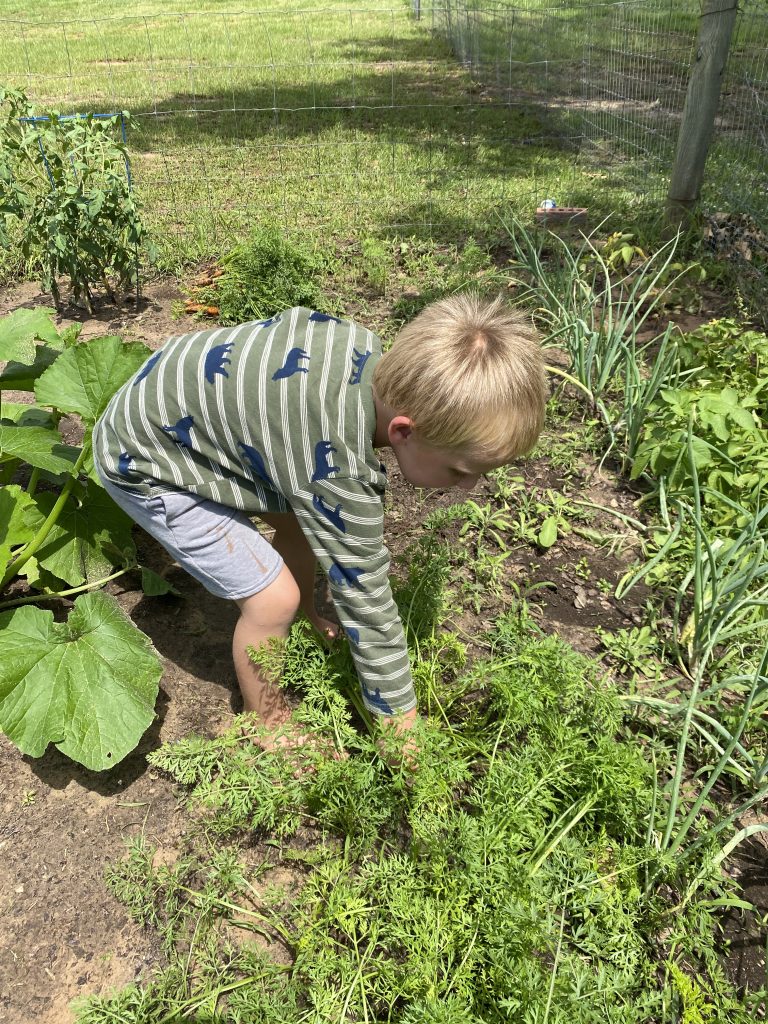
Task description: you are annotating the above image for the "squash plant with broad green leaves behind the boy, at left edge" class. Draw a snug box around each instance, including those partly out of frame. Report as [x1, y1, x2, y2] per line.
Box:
[0, 308, 162, 770]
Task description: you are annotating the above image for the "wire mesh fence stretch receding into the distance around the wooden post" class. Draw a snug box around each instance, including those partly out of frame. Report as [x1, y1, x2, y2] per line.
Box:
[428, 0, 768, 228]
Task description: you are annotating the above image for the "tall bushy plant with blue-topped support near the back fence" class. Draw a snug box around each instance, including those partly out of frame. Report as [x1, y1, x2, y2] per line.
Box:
[0, 89, 146, 311]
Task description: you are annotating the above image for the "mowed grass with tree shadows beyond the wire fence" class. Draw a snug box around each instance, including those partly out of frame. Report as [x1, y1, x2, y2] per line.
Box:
[0, 0, 700, 265]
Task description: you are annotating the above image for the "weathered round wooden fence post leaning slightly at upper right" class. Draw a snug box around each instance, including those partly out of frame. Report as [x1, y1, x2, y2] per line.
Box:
[667, 0, 737, 224]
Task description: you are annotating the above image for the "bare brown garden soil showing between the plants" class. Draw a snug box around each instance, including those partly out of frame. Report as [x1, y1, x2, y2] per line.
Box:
[0, 282, 768, 1024]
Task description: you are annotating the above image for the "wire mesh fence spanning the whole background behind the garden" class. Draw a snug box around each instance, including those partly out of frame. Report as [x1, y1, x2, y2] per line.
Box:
[0, 0, 768, 270]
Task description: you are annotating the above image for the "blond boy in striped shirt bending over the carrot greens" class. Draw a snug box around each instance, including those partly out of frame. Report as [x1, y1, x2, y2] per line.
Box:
[93, 294, 545, 741]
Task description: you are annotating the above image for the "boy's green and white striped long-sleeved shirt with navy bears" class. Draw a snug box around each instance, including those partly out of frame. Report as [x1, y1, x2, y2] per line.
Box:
[93, 307, 416, 715]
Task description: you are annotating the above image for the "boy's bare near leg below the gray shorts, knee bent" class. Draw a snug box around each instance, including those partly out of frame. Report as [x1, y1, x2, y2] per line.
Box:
[232, 565, 301, 728]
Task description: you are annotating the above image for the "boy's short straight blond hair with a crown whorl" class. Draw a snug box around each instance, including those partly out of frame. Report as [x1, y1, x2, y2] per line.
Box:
[373, 292, 547, 465]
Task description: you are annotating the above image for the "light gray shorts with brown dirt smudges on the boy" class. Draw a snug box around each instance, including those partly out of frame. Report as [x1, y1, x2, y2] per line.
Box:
[99, 474, 283, 601]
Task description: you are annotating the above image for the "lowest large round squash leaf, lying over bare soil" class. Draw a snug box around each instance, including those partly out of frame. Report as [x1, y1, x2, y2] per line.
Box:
[0, 593, 163, 771]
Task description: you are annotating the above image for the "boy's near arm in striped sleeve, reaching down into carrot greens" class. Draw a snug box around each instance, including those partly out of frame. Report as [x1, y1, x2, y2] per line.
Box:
[291, 477, 416, 720]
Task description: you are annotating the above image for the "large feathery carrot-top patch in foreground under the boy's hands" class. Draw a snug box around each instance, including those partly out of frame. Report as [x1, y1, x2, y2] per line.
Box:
[77, 520, 765, 1024]
